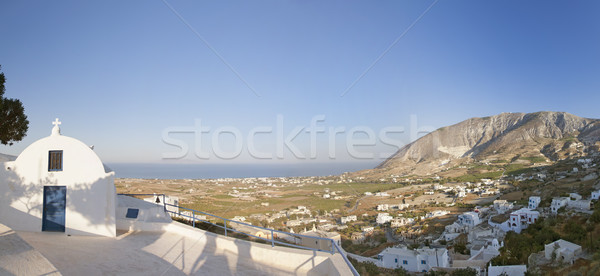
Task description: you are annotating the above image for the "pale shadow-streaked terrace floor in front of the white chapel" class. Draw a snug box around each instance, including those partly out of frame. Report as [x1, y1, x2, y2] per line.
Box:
[11, 226, 340, 275]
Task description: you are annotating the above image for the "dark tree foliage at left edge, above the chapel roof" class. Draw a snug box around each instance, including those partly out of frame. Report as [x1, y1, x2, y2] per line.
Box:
[0, 67, 29, 145]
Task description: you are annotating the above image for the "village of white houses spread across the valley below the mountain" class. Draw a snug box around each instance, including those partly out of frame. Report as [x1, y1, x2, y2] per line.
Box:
[115, 156, 600, 275]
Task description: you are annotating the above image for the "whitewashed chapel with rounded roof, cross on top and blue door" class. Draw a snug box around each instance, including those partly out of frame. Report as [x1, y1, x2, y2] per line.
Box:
[0, 119, 116, 237]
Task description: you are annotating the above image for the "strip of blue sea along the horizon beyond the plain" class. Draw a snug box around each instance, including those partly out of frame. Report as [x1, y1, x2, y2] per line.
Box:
[106, 162, 377, 179]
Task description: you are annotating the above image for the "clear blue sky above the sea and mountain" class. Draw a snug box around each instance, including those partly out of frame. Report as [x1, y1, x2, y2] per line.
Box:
[0, 0, 600, 164]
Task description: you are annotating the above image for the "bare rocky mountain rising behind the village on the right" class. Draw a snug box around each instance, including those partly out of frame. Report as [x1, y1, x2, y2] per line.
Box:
[376, 112, 600, 175]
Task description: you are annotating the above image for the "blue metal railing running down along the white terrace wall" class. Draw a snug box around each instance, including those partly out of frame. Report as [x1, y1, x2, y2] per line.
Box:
[119, 194, 359, 276]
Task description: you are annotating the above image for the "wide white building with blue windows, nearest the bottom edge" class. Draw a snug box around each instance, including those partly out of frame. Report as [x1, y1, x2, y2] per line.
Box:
[377, 247, 450, 272]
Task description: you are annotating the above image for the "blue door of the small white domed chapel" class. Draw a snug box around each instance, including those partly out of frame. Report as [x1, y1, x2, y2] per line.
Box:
[42, 186, 67, 232]
